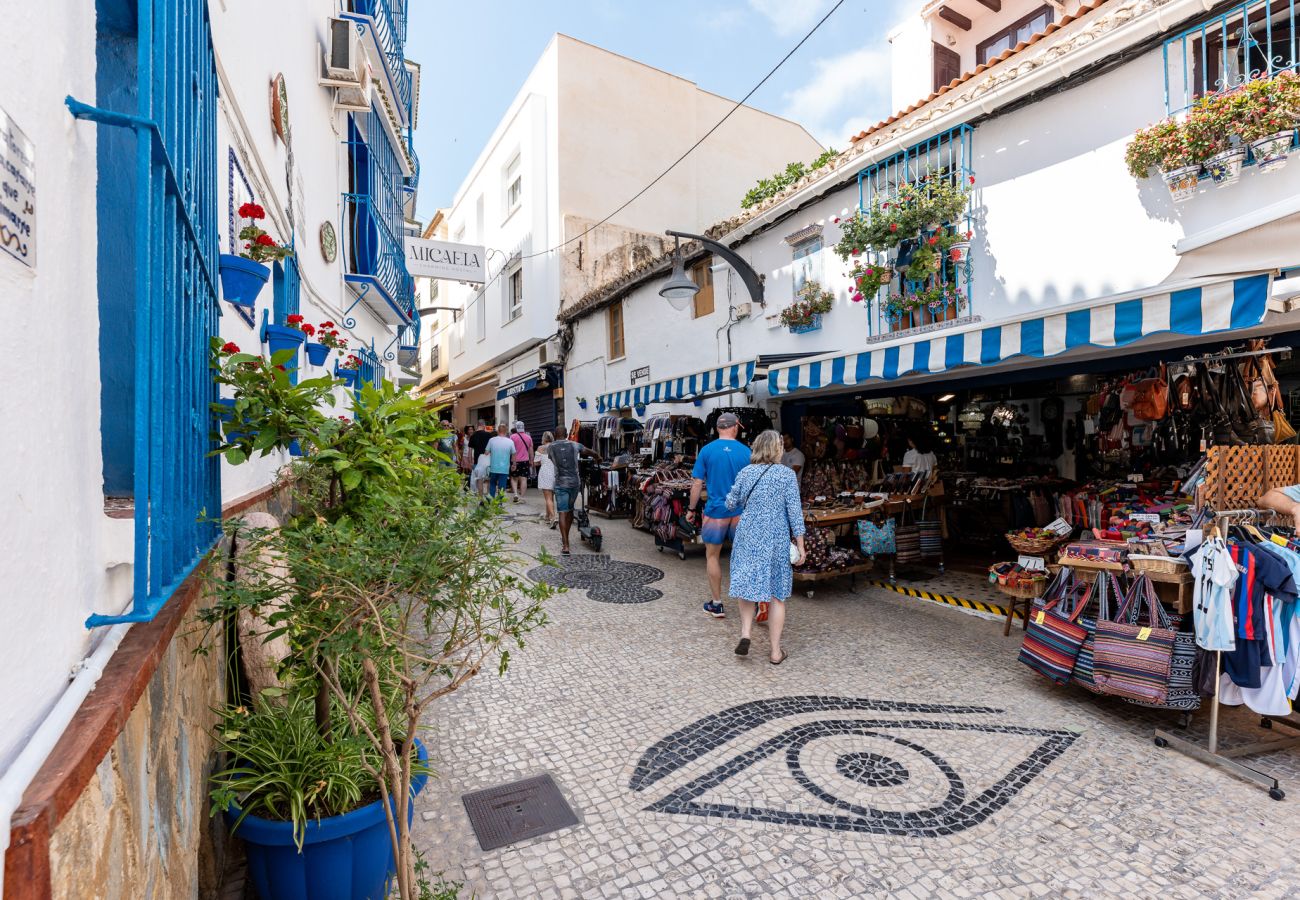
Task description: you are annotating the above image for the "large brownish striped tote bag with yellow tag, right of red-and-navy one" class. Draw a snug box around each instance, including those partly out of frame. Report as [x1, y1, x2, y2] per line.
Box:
[1092, 575, 1178, 705]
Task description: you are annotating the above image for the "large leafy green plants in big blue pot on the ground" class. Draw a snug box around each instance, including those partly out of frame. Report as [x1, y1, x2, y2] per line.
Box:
[203, 345, 550, 900]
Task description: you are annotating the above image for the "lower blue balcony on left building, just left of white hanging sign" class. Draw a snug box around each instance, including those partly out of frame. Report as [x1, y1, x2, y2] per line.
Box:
[343, 108, 415, 323]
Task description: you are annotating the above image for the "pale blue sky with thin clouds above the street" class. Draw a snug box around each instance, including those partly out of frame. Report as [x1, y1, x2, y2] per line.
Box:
[406, 0, 918, 221]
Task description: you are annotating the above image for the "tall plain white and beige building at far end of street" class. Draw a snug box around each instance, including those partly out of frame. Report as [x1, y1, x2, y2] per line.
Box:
[436, 35, 822, 432]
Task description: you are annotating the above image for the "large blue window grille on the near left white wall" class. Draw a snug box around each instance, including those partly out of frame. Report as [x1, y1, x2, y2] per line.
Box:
[76, 0, 221, 627]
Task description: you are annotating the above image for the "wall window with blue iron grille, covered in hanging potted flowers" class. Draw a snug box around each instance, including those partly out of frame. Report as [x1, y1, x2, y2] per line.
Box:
[858, 125, 974, 336]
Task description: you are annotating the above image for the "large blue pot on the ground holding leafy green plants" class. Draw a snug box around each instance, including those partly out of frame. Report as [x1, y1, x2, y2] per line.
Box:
[226, 740, 429, 900]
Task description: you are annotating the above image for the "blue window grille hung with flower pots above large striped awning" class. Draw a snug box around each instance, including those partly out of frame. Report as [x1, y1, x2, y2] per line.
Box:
[858, 125, 974, 336]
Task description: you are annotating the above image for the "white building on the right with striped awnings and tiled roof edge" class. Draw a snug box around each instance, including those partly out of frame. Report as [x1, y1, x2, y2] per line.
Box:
[562, 0, 1300, 421]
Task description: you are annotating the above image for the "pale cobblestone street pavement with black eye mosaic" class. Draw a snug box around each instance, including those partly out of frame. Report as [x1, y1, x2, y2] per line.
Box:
[416, 506, 1300, 899]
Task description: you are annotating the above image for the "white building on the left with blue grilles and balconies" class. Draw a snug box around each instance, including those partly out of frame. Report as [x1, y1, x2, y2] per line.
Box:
[0, 0, 419, 896]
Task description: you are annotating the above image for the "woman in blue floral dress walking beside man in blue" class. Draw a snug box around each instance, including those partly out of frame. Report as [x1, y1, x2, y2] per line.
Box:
[727, 430, 803, 666]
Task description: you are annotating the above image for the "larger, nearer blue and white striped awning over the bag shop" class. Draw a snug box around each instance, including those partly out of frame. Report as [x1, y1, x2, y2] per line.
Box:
[767, 273, 1271, 397]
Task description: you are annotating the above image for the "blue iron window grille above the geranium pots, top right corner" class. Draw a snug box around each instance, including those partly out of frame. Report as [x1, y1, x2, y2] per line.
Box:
[1164, 0, 1300, 114]
